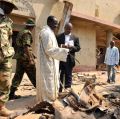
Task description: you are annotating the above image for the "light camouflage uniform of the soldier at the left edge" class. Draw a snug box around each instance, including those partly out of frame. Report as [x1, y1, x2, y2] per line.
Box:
[0, 17, 14, 105]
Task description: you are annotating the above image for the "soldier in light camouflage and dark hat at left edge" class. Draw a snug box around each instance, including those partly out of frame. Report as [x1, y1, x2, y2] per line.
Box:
[0, 0, 17, 116]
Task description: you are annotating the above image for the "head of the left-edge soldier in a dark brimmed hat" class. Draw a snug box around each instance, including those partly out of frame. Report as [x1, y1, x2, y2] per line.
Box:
[0, 0, 18, 14]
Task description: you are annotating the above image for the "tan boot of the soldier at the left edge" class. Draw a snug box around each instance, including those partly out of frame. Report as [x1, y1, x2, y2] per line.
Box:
[0, 105, 14, 117]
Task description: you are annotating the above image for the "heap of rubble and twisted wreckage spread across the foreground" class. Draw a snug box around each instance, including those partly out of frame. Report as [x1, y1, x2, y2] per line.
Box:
[4, 73, 120, 119]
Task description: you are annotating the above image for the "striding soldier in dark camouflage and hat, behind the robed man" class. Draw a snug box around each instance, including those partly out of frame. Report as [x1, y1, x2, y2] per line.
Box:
[10, 19, 36, 99]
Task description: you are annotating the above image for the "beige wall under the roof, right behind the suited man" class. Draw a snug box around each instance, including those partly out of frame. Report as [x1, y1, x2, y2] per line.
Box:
[71, 20, 96, 71]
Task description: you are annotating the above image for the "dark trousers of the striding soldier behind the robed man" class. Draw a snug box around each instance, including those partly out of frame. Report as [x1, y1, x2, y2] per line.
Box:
[11, 60, 36, 92]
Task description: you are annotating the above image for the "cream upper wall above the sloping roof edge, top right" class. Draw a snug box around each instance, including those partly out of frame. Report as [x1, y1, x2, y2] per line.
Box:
[68, 0, 120, 25]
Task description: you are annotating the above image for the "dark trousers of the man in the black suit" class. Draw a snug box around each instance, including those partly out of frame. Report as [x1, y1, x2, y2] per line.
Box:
[59, 62, 73, 92]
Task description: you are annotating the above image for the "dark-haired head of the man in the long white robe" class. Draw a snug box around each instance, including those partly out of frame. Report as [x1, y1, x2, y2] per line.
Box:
[47, 16, 58, 31]
